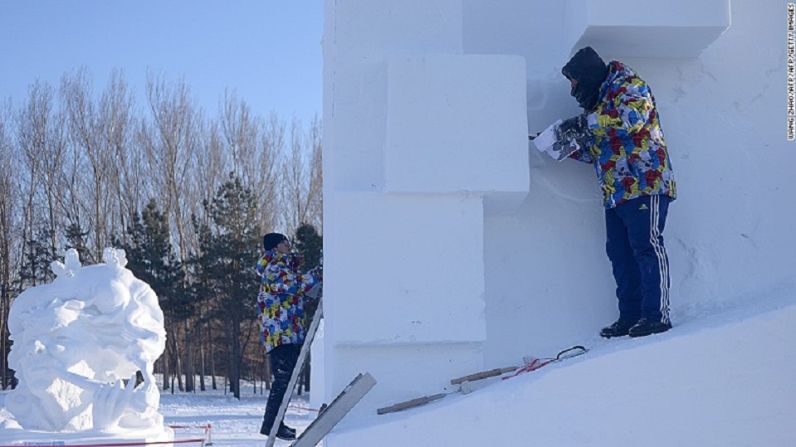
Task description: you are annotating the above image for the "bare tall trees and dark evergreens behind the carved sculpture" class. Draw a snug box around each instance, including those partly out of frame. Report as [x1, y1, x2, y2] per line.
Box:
[0, 69, 323, 397]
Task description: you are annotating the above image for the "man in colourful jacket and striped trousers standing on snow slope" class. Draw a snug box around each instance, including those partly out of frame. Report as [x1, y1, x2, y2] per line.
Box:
[537, 47, 676, 338]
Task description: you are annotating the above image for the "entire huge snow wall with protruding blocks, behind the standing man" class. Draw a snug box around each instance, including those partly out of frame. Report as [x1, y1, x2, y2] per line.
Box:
[314, 0, 796, 447]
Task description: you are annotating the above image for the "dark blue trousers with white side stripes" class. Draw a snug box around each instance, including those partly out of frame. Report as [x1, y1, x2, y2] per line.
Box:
[605, 195, 670, 324]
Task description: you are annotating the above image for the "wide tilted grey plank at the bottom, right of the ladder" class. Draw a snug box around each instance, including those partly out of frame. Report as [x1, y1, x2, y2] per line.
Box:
[291, 373, 376, 447]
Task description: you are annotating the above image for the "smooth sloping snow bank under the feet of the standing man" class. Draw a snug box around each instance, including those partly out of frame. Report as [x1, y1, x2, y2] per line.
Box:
[326, 289, 796, 447]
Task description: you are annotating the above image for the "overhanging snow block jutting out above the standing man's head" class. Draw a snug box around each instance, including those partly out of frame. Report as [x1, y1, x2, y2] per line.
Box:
[566, 0, 728, 58]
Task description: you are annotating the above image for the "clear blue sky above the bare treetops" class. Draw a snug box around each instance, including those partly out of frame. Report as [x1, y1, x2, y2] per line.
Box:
[0, 0, 323, 122]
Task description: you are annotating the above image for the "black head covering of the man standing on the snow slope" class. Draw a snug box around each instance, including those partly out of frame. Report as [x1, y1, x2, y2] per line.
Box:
[561, 47, 608, 110]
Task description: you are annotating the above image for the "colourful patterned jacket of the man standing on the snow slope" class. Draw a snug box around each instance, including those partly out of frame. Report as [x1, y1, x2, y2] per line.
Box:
[566, 61, 677, 208]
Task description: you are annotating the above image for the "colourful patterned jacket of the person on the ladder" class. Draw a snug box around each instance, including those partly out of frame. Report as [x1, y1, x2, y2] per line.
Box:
[256, 249, 320, 352]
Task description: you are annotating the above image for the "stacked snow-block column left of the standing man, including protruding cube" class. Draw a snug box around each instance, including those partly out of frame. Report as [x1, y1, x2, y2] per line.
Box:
[324, 0, 529, 420]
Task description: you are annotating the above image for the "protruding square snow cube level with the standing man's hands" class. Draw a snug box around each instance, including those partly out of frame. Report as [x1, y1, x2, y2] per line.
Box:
[384, 55, 529, 193]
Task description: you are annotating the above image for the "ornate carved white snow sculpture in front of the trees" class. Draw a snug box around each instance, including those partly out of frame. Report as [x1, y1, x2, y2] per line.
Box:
[5, 248, 166, 435]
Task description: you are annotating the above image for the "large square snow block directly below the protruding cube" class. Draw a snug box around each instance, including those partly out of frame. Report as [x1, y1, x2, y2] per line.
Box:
[324, 192, 486, 344]
